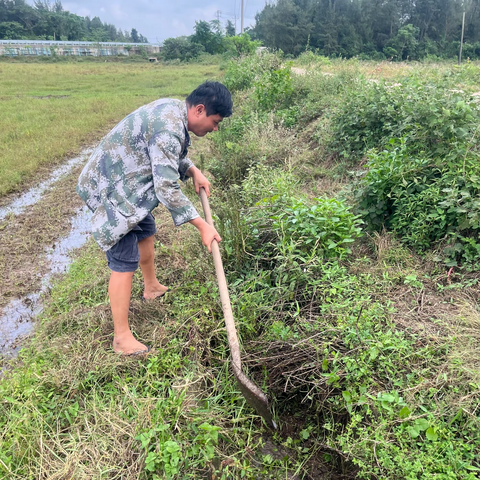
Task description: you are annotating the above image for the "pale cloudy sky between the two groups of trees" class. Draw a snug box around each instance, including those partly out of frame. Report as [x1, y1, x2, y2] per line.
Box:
[54, 0, 266, 43]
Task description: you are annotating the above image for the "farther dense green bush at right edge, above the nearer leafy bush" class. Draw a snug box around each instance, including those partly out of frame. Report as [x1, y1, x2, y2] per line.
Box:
[330, 79, 480, 157]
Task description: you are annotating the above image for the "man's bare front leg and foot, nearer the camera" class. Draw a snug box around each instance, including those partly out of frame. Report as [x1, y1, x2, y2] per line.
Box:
[108, 271, 147, 355]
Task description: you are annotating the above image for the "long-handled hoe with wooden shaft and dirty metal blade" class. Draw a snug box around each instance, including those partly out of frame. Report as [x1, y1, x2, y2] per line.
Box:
[200, 188, 277, 428]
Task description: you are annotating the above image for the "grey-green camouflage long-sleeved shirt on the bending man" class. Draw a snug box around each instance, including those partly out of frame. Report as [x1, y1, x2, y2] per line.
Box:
[77, 99, 199, 251]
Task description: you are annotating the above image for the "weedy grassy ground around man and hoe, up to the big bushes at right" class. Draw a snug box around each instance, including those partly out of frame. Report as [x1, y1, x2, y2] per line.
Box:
[0, 57, 480, 480]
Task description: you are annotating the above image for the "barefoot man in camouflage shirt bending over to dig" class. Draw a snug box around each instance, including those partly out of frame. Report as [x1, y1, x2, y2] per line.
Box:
[77, 82, 232, 355]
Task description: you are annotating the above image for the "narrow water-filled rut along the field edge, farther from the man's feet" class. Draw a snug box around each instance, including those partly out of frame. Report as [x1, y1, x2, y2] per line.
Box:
[0, 149, 93, 221]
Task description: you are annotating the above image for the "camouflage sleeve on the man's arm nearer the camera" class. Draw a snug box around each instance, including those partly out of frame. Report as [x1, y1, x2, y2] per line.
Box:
[148, 131, 199, 226]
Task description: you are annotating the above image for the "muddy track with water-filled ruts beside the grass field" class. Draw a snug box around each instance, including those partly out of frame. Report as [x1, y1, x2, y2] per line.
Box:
[0, 151, 93, 355]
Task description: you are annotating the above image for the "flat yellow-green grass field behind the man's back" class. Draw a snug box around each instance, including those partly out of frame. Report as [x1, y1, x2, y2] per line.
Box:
[0, 63, 219, 197]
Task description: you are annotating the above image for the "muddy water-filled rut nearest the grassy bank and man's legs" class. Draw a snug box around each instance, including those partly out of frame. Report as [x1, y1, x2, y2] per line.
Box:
[0, 207, 92, 356]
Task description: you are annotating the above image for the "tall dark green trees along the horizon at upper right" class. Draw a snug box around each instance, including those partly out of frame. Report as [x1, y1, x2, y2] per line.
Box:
[249, 0, 480, 60]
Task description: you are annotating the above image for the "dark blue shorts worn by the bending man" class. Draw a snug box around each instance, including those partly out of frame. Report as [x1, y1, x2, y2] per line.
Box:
[107, 213, 157, 273]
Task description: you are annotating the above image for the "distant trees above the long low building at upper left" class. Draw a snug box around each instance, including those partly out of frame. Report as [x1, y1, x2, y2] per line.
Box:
[0, 0, 148, 43]
